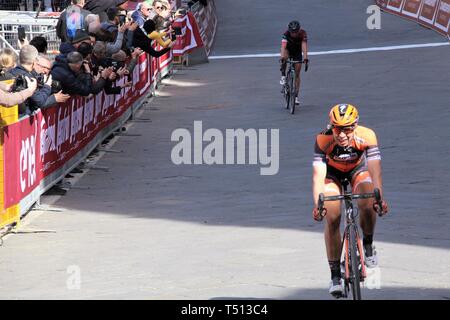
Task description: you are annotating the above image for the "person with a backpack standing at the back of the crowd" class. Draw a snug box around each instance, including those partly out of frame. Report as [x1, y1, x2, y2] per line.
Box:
[56, 0, 91, 42]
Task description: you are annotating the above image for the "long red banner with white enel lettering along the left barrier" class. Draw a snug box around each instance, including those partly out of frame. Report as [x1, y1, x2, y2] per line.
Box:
[3, 54, 170, 208]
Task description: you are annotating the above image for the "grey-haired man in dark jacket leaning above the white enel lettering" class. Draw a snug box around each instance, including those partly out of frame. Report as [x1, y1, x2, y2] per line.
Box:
[10, 45, 52, 114]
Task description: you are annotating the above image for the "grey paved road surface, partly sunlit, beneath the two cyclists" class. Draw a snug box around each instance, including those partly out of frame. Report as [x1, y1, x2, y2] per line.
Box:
[0, 0, 450, 299]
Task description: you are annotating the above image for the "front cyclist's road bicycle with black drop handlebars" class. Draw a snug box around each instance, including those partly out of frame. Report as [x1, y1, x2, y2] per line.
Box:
[318, 179, 382, 300]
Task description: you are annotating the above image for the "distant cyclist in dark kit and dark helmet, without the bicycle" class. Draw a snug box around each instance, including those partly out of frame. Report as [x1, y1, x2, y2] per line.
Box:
[280, 20, 308, 104]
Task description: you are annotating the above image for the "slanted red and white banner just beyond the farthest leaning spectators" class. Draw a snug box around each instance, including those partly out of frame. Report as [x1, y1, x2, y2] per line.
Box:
[172, 12, 203, 56]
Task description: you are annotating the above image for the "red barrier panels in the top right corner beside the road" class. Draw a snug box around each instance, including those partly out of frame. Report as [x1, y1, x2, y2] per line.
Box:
[376, 0, 450, 39]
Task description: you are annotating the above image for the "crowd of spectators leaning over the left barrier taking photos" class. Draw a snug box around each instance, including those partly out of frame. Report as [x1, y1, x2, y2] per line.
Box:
[0, 0, 185, 115]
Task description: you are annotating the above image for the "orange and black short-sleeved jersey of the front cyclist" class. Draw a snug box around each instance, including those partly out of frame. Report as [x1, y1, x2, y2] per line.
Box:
[313, 126, 381, 172]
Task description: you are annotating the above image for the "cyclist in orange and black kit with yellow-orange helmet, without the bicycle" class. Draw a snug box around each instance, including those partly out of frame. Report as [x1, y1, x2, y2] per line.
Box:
[313, 104, 388, 296]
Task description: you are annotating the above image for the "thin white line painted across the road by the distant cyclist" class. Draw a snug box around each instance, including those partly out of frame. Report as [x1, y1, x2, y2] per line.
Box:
[209, 42, 450, 60]
